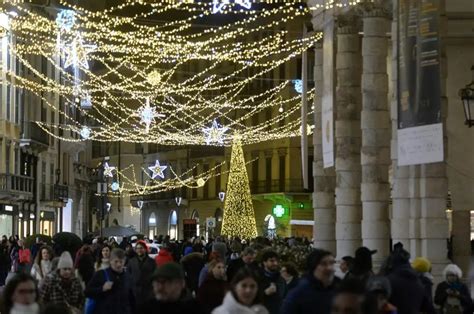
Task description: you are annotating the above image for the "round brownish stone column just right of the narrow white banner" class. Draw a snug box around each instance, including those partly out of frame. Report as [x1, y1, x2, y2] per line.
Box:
[335, 16, 362, 258]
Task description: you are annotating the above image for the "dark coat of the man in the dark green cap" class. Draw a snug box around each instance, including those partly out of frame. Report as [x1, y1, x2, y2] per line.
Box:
[138, 296, 203, 314]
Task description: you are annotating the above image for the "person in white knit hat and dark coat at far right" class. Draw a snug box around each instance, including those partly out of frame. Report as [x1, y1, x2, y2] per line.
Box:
[434, 264, 472, 314]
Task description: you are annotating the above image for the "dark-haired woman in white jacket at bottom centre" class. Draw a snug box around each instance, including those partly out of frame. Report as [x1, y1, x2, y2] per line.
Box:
[212, 268, 269, 314]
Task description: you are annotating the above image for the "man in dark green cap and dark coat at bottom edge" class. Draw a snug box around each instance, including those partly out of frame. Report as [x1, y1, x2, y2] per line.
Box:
[139, 262, 202, 314]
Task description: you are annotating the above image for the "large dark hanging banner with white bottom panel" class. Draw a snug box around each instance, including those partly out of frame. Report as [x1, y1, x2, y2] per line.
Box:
[398, 0, 444, 166]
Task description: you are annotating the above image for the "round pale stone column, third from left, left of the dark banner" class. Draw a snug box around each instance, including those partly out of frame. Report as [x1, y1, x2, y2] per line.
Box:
[361, 5, 390, 260]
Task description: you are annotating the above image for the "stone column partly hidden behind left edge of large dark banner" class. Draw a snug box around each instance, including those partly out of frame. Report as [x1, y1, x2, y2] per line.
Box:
[390, 1, 410, 249]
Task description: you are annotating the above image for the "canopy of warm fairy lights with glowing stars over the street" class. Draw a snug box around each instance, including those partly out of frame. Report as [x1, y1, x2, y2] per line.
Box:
[0, 0, 359, 195]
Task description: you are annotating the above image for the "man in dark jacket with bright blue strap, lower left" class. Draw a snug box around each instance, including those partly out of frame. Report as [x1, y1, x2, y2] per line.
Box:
[85, 248, 135, 314]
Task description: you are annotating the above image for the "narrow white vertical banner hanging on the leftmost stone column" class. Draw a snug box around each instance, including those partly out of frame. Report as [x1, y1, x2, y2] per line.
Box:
[321, 21, 334, 168]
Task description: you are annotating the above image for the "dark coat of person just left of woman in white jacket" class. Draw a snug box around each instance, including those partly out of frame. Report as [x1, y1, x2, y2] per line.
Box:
[197, 274, 229, 313]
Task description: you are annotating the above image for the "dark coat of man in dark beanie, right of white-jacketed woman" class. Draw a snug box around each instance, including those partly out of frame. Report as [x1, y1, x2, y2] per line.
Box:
[281, 275, 339, 314]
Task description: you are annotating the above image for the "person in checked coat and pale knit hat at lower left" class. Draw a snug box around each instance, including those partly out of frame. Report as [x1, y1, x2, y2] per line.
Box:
[40, 251, 84, 312]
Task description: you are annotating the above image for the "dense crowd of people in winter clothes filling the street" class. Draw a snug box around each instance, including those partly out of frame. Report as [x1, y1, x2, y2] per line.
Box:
[0, 236, 473, 314]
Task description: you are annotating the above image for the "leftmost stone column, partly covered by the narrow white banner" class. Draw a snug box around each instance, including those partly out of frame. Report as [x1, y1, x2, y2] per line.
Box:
[313, 43, 336, 254]
